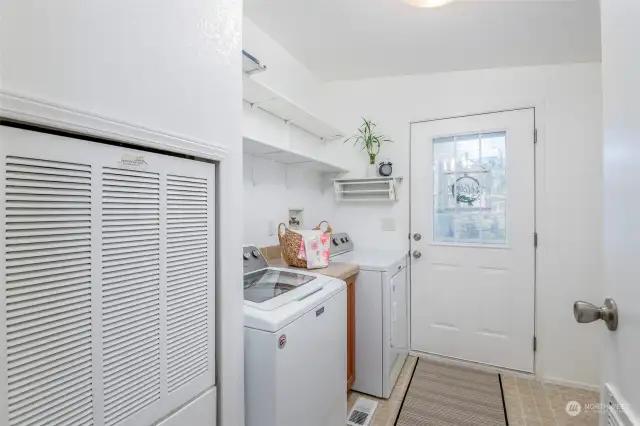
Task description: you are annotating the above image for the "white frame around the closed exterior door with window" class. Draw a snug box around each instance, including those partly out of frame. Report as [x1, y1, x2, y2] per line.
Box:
[407, 104, 544, 377]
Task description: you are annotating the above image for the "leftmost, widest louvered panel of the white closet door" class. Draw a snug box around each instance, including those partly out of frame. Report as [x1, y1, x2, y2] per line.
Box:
[4, 156, 92, 426]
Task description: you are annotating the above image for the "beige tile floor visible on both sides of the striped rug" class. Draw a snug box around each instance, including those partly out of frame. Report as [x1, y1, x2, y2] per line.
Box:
[348, 356, 600, 426]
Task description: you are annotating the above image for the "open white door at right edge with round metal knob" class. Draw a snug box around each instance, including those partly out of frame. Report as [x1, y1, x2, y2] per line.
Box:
[600, 0, 640, 425]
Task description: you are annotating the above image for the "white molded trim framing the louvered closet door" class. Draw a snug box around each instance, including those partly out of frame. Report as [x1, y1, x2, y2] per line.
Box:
[0, 87, 244, 425]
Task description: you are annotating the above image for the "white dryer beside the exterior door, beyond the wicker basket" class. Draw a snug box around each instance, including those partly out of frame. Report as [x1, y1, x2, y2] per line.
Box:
[331, 233, 409, 398]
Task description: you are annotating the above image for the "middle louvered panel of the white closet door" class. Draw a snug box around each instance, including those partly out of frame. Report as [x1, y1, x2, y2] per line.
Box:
[102, 168, 160, 425]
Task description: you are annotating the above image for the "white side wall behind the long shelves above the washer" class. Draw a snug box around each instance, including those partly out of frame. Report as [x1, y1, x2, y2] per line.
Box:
[242, 17, 348, 247]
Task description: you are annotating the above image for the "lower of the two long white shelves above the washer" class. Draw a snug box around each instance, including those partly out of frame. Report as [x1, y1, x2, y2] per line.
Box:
[242, 138, 347, 173]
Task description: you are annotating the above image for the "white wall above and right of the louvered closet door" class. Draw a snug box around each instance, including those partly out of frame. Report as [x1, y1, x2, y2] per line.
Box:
[0, 0, 244, 426]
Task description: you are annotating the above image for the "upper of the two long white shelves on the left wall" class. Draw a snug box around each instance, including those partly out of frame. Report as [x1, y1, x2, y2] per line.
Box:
[242, 74, 343, 139]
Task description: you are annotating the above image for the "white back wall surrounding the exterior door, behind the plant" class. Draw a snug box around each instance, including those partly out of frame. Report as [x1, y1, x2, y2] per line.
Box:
[325, 63, 603, 385]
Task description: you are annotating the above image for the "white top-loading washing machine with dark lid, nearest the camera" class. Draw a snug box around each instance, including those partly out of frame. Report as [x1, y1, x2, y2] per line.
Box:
[242, 246, 347, 426]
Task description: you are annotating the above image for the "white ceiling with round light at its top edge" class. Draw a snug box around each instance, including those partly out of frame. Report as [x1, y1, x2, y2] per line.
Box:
[244, 0, 600, 80]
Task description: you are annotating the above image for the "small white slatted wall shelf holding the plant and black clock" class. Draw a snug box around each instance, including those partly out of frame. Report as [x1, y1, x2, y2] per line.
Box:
[333, 176, 402, 202]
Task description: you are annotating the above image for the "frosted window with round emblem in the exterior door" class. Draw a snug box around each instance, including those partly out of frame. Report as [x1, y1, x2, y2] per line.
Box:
[433, 132, 507, 245]
